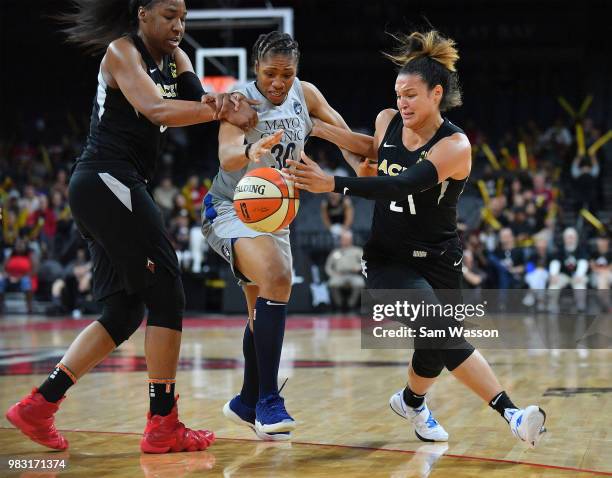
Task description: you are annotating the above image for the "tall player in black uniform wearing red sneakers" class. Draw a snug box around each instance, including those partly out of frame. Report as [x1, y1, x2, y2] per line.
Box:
[6, 0, 257, 453]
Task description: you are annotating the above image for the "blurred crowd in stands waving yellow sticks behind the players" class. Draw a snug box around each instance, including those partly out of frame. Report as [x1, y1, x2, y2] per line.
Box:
[0, 111, 612, 317]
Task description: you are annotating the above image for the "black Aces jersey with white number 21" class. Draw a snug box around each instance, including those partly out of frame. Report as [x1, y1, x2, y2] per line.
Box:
[364, 112, 467, 260]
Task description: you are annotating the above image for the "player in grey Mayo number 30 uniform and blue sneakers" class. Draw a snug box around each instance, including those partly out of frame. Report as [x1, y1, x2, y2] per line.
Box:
[202, 31, 364, 440]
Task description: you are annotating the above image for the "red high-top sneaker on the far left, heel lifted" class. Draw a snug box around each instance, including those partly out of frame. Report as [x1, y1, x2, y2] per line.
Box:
[6, 388, 68, 450]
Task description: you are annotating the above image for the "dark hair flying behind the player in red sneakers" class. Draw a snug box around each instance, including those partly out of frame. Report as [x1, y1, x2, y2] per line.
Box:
[55, 0, 164, 55]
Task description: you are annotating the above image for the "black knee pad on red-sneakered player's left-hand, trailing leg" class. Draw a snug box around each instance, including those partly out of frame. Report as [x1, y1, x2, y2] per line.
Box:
[98, 292, 144, 347]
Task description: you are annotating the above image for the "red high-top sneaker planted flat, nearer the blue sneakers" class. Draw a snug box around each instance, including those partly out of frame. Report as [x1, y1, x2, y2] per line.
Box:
[140, 395, 215, 453]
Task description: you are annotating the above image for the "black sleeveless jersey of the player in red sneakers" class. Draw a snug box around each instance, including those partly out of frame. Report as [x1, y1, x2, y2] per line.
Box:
[77, 34, 178, 181]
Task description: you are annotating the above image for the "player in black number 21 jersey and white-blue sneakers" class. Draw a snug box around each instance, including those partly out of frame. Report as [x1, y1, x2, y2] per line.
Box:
[284, 31, 545, 446]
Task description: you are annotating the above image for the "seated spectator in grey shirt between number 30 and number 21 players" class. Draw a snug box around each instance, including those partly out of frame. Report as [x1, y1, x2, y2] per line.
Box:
[325, 230, 365, 310]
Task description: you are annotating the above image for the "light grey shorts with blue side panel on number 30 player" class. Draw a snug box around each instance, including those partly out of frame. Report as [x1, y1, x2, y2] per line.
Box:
[202, 194, 293, 286]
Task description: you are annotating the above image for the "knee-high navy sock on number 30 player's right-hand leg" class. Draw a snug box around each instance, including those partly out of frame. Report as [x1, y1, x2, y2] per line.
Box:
[253, 297, 287, 399]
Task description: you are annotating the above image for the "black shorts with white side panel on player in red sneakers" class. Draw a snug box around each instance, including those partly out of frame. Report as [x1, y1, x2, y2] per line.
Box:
[68, 162, 180, 300]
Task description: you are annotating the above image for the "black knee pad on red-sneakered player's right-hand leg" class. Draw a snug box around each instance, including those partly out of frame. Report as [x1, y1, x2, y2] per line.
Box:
[141, 269, 185, 332]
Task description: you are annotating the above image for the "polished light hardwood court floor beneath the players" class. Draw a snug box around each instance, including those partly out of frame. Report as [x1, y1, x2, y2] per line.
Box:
[0, 317, 612, 478]
